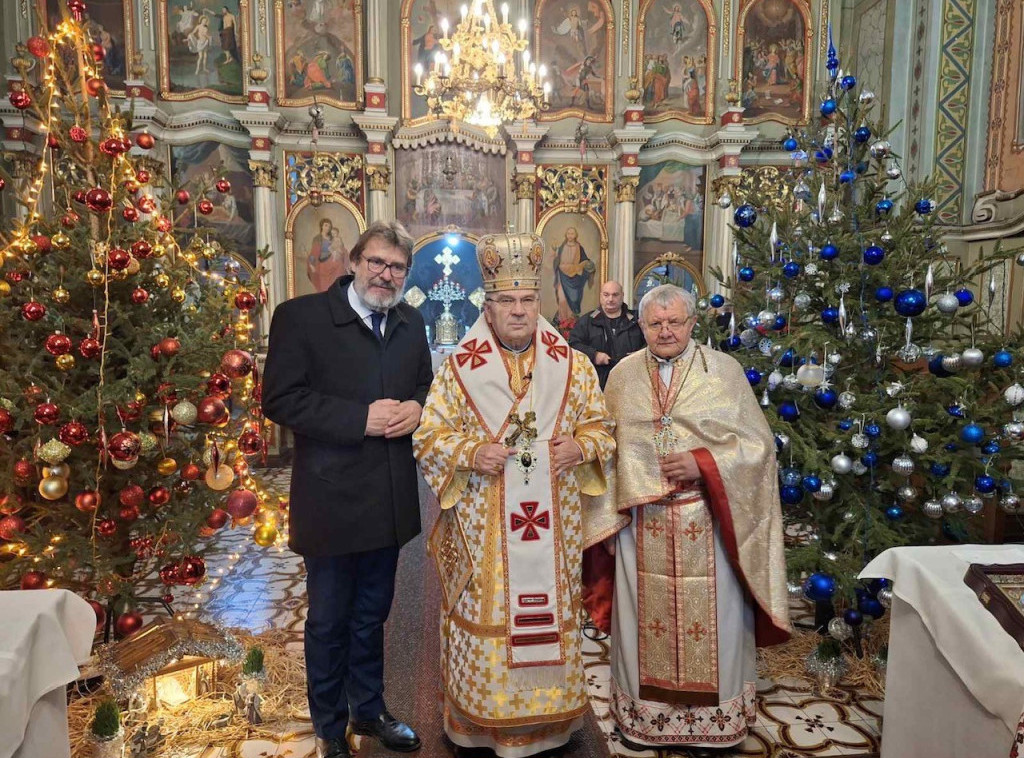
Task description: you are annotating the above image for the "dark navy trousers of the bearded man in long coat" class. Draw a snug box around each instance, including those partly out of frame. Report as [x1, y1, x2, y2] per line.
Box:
[305, 546, 398, 740]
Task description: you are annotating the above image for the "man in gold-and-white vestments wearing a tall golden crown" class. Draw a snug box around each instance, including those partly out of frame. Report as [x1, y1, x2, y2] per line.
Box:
[413, 235, 615, 758]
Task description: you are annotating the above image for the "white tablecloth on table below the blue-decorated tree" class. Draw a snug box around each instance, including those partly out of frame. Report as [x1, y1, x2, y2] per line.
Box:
[860, 545, 1024, 758]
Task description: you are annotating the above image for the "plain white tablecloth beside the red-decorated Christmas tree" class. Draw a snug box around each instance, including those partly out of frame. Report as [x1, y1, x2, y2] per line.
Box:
[0, 590, 96, 758]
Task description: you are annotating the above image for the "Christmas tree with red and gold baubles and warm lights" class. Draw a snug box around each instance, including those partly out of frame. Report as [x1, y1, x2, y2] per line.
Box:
[0, 0, 280, 635]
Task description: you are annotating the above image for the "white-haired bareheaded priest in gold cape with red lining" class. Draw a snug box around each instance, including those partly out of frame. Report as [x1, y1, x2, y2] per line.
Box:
[585, 285, 790, 747]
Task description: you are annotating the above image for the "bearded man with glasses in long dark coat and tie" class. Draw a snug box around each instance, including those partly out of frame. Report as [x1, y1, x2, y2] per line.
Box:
[263, 221, 432, 758]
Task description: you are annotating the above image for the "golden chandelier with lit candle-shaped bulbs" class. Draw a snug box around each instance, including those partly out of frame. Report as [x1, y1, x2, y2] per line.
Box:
[413, 0, 551, 136]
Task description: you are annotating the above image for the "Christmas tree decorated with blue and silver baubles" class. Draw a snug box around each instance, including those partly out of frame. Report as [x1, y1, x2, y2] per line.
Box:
[701, 26, 1024, 641]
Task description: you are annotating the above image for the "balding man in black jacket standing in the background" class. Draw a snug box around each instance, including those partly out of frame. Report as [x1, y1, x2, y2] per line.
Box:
[569, 282, 647, 389]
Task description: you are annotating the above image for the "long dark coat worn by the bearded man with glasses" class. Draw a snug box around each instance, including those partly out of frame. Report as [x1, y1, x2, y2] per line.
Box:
[263, 277, 432, 555]
